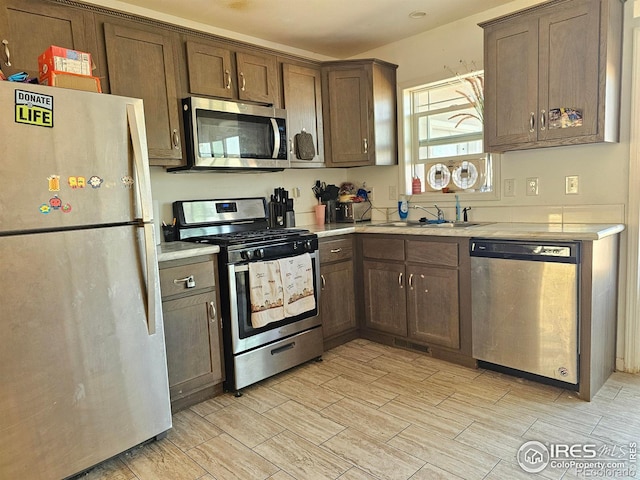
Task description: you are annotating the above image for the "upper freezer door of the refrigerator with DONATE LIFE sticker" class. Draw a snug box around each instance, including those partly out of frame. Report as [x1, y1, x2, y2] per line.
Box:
[0, 82, 148, 232]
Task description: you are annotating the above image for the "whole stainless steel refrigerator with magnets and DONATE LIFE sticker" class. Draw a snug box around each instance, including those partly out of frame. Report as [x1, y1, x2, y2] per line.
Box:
[0, 81, 171, 480]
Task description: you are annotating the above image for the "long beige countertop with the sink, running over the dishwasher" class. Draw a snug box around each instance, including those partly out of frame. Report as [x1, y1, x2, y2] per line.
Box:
[302, 223, 625, 240]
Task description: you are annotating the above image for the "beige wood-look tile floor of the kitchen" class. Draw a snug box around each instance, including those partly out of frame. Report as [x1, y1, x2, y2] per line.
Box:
[80, 339, 640, 480]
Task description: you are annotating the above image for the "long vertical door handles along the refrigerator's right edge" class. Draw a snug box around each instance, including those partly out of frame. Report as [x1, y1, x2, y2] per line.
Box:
[127, 101, 161, 335]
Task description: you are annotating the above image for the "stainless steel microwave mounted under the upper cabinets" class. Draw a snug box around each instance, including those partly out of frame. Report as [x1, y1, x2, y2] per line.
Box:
[167, 97, 290, 172]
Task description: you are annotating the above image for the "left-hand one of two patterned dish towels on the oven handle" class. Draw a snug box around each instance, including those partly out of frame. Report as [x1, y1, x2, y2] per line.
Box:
[249, 260, 284, 328]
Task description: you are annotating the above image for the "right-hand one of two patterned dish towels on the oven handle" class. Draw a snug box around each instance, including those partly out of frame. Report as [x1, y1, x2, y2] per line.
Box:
[278, 253, 316, 317]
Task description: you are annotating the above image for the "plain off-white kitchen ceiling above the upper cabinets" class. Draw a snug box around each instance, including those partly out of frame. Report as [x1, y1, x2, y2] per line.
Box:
[111, 0, 512, 59]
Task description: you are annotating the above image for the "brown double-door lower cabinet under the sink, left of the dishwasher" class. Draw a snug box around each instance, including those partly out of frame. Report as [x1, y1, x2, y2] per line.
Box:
[358, 234, 474, 365]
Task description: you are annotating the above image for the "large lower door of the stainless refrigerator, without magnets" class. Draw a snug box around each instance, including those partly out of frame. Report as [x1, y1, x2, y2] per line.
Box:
[0, 226, 171, 480]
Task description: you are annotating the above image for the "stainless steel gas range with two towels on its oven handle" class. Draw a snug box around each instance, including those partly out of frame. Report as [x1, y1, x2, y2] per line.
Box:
[173, 198, 322, 395]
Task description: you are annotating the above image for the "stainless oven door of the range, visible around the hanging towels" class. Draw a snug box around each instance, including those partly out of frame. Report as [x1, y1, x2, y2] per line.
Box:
[227, 251, 321, 355]
